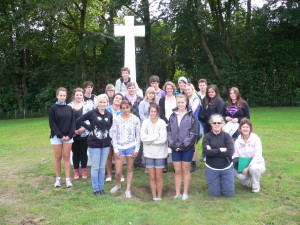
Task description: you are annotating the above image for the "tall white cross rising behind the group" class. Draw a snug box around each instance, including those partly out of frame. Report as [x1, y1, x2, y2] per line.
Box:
[114, 16, 145, 82]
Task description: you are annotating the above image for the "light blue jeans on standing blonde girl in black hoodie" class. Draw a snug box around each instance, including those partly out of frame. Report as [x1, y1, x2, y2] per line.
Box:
[88, 147, 109, 191]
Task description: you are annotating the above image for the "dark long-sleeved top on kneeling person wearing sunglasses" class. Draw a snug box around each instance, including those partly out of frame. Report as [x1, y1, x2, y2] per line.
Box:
[202, 131, 234, 169]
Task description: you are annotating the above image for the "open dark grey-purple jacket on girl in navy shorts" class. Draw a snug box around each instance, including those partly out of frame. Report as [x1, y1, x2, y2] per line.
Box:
[168, 108, 199, 151]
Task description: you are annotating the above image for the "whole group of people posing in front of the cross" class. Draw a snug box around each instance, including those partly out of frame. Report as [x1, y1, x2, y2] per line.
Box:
[49, 67, 265, 201]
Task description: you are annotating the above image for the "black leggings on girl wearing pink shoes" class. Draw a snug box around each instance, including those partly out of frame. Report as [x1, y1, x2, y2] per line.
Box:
[72, 136, 88, 169]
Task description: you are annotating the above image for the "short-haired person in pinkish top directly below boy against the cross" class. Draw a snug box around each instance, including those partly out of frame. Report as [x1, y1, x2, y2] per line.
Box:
[125, 82, 144, 168]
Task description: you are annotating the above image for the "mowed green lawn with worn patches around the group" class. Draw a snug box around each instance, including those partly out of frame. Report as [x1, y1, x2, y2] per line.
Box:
[0, 108, 300, 224]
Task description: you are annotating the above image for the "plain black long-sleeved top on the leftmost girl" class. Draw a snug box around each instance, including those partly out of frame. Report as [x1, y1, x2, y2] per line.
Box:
[49, 105, 75, 139]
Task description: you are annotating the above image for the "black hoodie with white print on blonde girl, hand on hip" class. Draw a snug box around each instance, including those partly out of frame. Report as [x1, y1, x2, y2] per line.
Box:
[76, 109, 113, 148]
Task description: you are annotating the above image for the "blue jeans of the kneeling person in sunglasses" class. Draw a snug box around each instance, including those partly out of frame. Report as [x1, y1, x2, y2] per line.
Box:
[205, 166, 235, 197]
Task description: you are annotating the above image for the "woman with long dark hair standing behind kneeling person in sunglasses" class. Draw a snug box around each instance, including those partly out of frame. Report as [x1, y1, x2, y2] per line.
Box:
[204, 84, 224, 133]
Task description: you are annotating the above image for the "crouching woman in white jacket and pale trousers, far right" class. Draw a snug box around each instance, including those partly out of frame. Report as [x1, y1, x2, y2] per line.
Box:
[233, 118, 266, 192]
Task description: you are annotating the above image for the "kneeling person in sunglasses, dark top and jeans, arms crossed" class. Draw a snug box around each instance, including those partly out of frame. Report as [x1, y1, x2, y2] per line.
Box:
[202, 114, 234, 197]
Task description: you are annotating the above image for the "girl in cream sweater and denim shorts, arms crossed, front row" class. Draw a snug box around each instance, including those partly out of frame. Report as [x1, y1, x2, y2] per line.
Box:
[141, 104, 168, 201]
